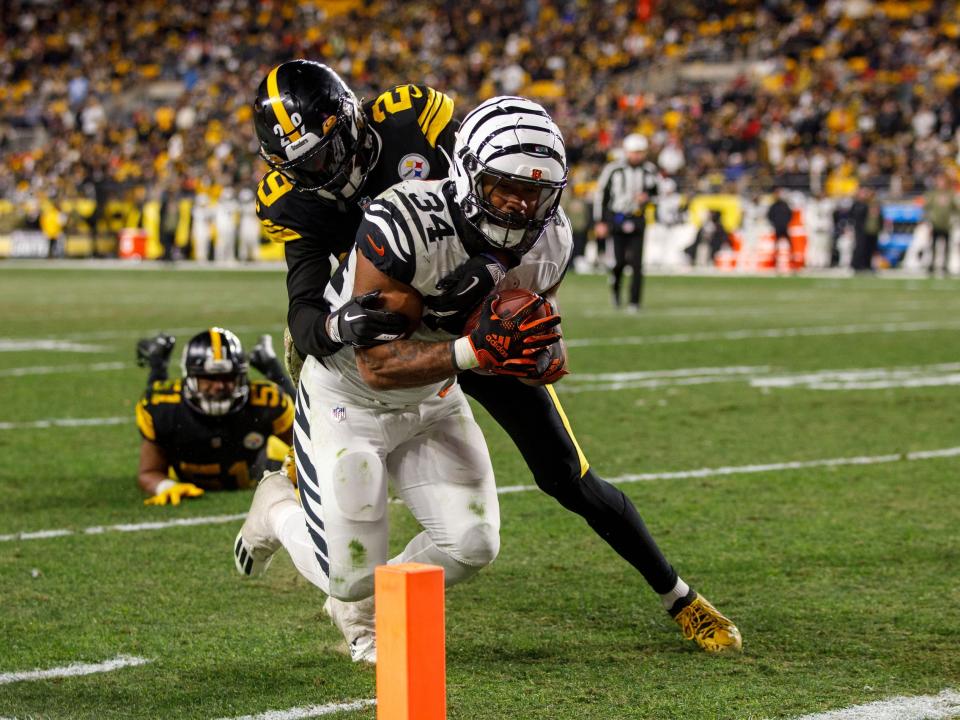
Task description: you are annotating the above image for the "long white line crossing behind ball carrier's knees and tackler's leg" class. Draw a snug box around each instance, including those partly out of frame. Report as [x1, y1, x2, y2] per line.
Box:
[0, 446, 960, 542]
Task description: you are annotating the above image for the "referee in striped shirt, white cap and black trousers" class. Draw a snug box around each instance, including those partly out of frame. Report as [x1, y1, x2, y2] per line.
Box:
[593, 133, 660, 312]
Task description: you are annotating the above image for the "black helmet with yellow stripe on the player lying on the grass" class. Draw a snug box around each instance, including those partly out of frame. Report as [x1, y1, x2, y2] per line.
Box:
[181, 327, 250, 415]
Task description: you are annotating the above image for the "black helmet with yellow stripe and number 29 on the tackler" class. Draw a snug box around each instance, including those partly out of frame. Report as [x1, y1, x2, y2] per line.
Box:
[253, 60, 379, 200]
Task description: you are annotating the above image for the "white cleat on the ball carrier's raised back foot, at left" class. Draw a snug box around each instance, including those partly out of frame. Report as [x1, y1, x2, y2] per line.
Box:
[233, 470, 297, 577]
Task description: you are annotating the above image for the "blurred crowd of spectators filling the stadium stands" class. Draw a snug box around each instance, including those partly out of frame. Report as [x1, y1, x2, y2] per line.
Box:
[0, 0, 960, 248]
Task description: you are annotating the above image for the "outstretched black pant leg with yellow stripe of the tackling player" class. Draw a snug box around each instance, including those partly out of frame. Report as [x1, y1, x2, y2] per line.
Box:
[458, 372, 677, 594]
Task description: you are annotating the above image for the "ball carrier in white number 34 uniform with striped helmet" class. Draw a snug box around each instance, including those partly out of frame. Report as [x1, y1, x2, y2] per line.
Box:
[237, 98, 573, 661]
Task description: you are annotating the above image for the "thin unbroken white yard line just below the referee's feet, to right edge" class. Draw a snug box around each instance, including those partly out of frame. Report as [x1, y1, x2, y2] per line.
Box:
[565, 322, 960, 347]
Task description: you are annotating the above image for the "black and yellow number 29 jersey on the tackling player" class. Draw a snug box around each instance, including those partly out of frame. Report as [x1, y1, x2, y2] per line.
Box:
[257, 85, 458, 356]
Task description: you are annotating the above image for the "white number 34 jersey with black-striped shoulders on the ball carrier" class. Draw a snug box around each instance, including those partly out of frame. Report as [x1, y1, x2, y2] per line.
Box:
[321, 180, 573, 406]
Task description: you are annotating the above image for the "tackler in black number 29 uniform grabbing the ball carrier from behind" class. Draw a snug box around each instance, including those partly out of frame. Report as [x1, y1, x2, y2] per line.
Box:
[236, 60, 740, 652]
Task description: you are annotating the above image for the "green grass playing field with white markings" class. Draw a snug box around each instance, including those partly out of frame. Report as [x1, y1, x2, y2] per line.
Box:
[0, 265, 960, 720]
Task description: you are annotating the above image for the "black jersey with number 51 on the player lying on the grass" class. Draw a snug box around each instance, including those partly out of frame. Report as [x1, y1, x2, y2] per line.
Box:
[136, 379, 293, 490]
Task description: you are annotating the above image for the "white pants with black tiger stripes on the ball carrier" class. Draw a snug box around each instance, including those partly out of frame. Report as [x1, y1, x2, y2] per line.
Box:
[278, 357, 500, 601]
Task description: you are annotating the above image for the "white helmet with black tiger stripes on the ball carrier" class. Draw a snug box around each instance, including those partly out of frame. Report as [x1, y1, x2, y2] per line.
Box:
[453, 96, 567, 255]
